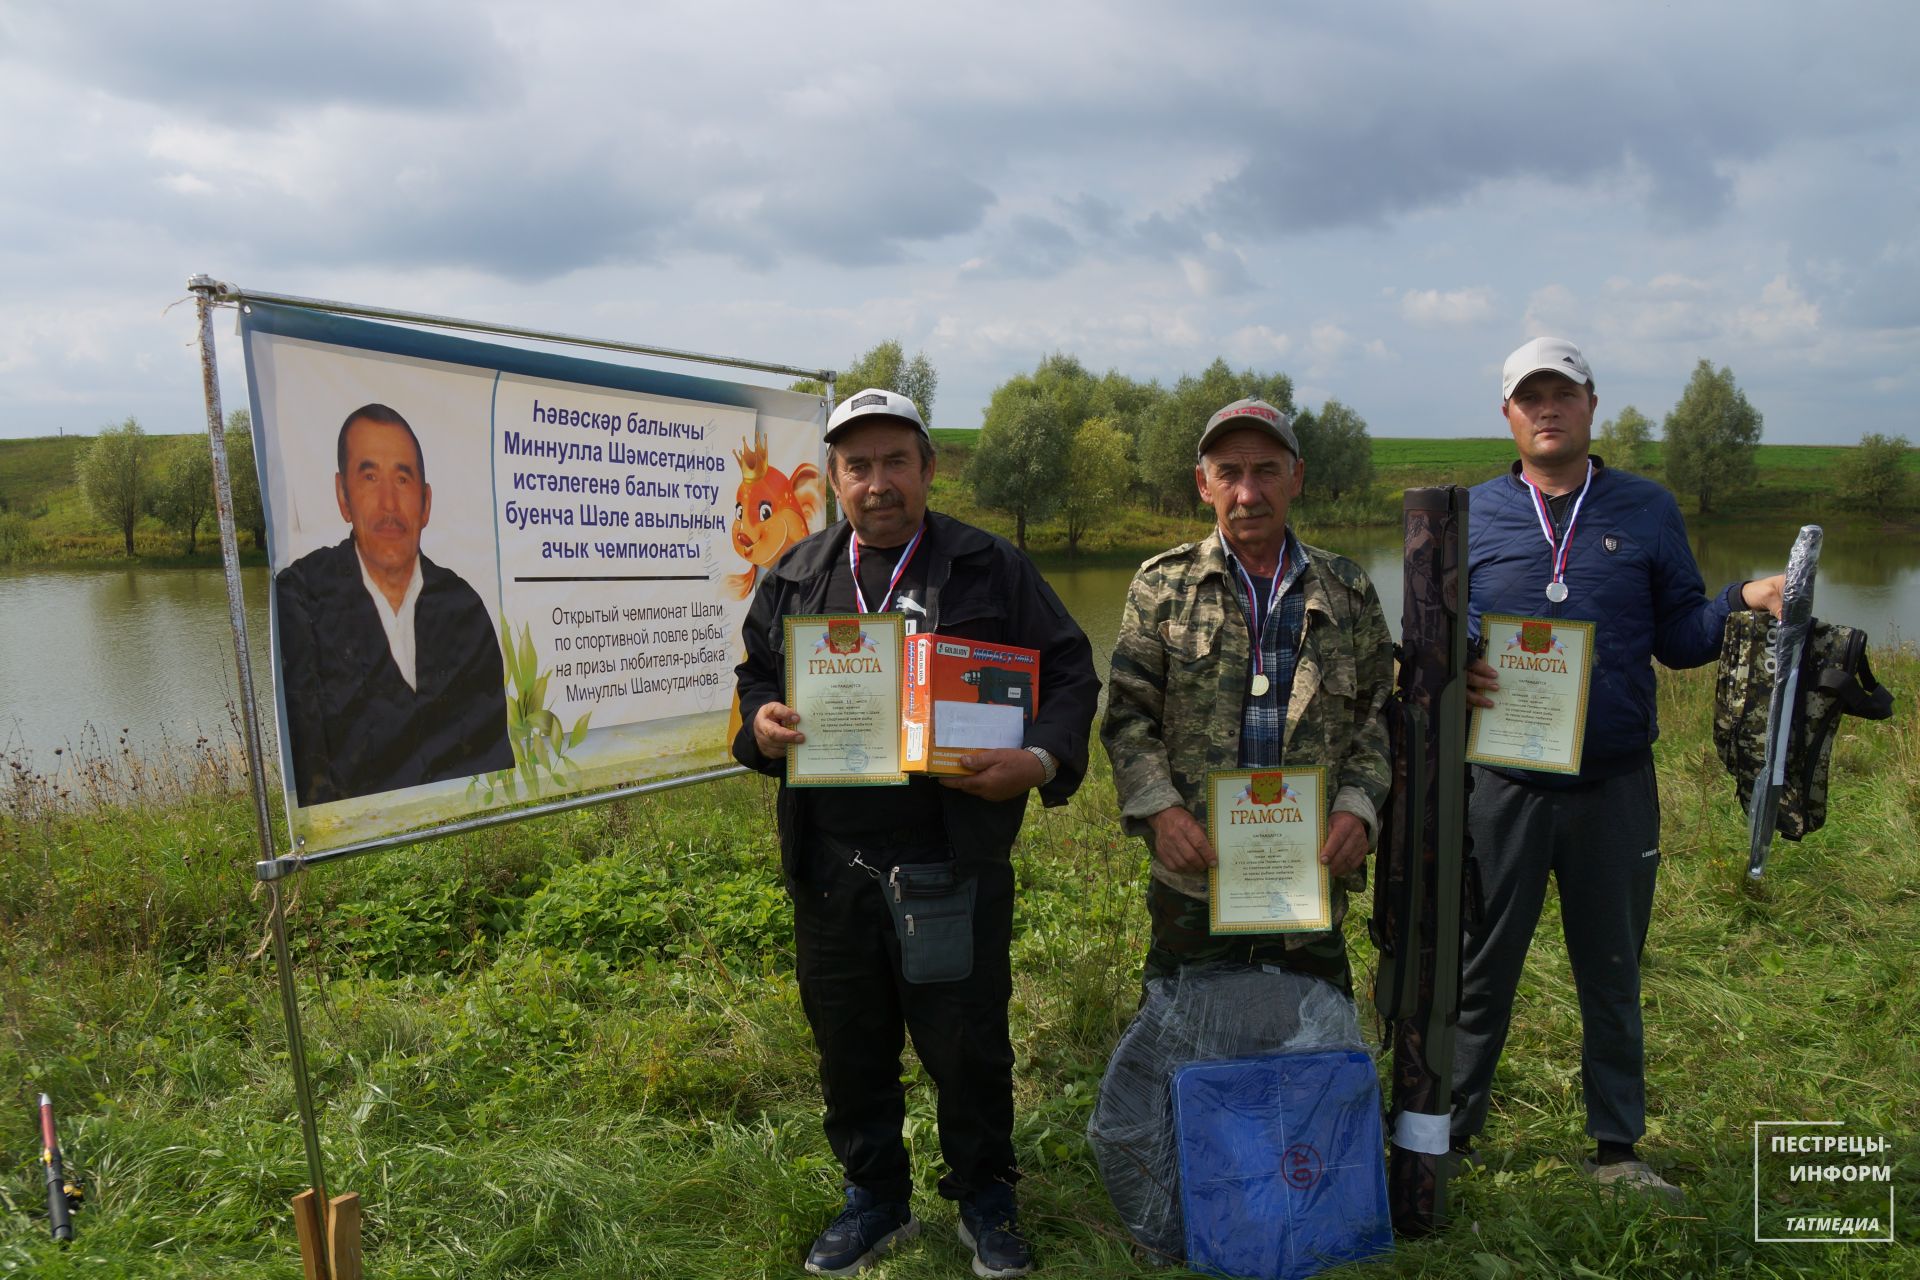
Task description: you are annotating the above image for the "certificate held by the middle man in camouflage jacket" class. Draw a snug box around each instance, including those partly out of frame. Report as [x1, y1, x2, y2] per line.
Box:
[1206, 766, 1332, 933]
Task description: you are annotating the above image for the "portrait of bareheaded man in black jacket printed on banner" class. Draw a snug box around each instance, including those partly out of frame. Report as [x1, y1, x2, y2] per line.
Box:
[275, 403, 513, 808]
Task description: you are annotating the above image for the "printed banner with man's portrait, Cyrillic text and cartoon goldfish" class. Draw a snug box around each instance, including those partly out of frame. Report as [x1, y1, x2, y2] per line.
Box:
[240, 303, 828, 852]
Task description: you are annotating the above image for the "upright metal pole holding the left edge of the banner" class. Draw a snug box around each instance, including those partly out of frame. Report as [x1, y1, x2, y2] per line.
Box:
[186, 276, 332, 1274]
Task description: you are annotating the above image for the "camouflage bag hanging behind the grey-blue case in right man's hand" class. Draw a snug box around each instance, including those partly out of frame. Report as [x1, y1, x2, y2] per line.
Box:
[1713, 612, 1893, 841]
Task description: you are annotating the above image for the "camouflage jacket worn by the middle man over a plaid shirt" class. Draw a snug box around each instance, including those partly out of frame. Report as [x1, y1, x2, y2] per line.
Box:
[1100, 530, 1394, 944]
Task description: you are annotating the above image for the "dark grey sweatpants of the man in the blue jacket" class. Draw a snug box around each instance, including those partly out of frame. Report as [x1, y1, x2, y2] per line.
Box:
[1453, 760, 1661, 1142]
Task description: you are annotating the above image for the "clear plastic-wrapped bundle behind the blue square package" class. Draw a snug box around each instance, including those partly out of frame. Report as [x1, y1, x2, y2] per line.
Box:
[1087, 965, 1363, 1261]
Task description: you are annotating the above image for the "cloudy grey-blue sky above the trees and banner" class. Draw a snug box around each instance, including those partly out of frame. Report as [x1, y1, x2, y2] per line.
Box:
[0, 0, 1920, 443]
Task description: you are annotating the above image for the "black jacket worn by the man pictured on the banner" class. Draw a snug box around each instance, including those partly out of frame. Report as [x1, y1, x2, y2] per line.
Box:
[273, 537, 513, 806]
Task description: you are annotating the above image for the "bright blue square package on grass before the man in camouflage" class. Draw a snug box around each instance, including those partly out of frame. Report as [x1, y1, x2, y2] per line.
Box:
[1173, 1050, 1394, 1280]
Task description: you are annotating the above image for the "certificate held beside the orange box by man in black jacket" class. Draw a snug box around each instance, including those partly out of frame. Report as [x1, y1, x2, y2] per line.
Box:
[783, 614, 906, 787]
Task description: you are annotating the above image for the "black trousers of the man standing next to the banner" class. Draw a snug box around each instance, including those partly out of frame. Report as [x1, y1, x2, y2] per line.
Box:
[793, 836, 1020, 1201]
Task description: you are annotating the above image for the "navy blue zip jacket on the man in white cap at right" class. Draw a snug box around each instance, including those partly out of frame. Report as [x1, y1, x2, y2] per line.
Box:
[1467, 457, 1745, 787]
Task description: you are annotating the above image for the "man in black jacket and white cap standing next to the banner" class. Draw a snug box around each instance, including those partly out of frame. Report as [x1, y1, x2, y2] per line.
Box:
[733, 390, 1100, 1276]
